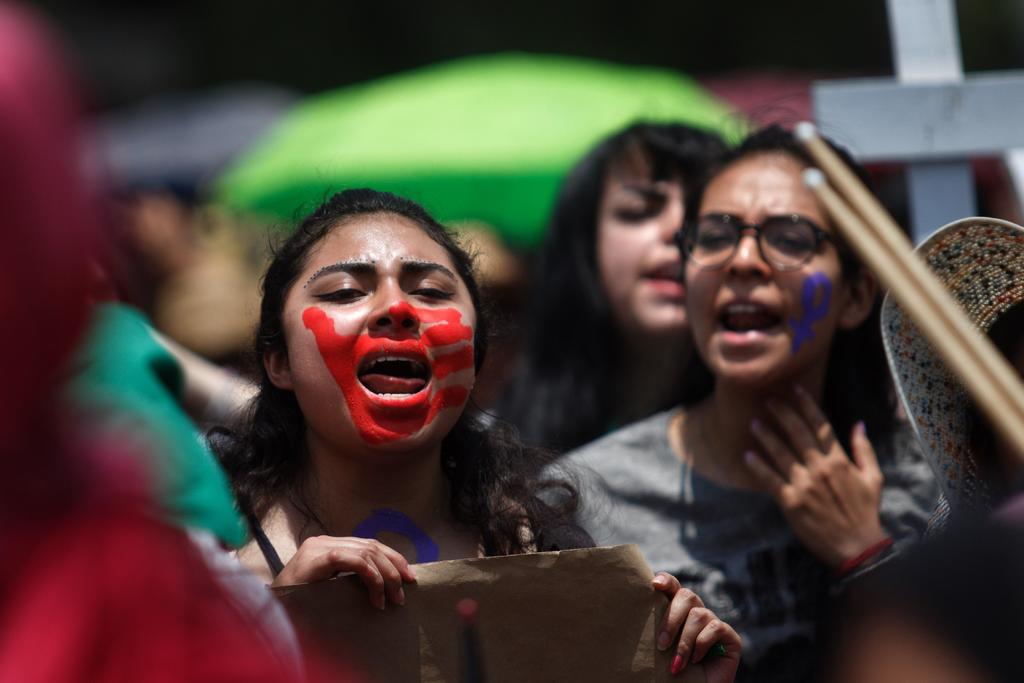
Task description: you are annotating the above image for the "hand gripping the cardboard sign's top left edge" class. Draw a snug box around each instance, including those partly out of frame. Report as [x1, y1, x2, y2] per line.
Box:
[271, 536, 416, 609]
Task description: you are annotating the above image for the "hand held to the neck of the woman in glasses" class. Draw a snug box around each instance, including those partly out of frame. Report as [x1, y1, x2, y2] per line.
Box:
[745, 386, 886, 568]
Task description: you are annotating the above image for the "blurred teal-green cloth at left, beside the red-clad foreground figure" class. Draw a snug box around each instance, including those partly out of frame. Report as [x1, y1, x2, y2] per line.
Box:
[70, 304, 245, 547]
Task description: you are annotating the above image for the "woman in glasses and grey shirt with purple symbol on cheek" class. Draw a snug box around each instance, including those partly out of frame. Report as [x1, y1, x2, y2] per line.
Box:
[567, 127, 937, 681]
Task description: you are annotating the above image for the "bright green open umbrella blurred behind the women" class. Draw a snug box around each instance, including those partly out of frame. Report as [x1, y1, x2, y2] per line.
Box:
[214, 53, 738, 247]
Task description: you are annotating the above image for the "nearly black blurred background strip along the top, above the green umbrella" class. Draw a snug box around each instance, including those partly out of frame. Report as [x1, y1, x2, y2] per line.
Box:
[28, 0, 1024, 110]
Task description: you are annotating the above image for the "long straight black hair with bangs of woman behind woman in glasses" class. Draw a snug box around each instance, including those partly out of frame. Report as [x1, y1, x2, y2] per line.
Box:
[497, 122, 725, 450]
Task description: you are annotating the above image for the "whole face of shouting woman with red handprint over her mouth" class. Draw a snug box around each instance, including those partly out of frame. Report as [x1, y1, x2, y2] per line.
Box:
[272, 214, 476, 458]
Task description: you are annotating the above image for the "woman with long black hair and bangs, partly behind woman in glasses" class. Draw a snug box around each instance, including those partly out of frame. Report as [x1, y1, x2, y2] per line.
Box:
[498, 123, 724, 451]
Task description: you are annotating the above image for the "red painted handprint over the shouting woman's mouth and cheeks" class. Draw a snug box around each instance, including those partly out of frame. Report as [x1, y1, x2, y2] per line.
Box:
[302, 302, 473, 443]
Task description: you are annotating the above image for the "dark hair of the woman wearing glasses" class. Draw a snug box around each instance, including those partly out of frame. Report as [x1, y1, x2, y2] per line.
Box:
[682, 125, 897, 449]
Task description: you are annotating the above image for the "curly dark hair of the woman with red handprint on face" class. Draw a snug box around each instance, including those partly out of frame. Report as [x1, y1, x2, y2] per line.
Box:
[211, 189, 589, 555]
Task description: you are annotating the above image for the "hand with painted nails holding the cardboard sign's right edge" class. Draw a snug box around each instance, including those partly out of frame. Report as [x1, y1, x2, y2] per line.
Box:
[652, 571, 740, 683]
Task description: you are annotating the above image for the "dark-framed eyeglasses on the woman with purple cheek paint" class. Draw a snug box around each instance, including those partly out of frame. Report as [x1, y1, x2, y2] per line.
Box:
[676, 213, 834, 270]
